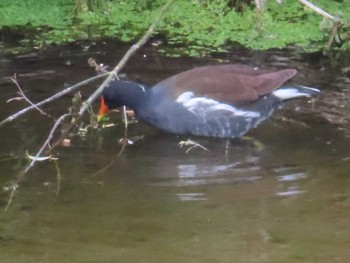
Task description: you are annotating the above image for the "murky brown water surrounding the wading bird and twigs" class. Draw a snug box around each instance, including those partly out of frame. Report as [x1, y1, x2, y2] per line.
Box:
[0, 43, 350, 263]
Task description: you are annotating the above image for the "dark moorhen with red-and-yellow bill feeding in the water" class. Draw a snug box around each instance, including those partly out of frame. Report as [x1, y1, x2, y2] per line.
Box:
[98, 64, 320, 139]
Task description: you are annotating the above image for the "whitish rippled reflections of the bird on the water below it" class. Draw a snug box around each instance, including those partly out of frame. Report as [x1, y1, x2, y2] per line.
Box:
[152, 157, 308, 201]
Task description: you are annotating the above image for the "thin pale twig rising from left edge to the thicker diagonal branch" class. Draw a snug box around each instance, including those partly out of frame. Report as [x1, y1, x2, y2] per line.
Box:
[0, 73, 108, 127]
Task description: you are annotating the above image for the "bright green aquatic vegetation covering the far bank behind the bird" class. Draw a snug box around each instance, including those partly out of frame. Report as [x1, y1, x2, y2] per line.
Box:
[0, 0, 350, 56]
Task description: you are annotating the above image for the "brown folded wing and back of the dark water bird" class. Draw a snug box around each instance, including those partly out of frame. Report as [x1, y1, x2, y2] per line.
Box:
[157, 64, 297, 104]
